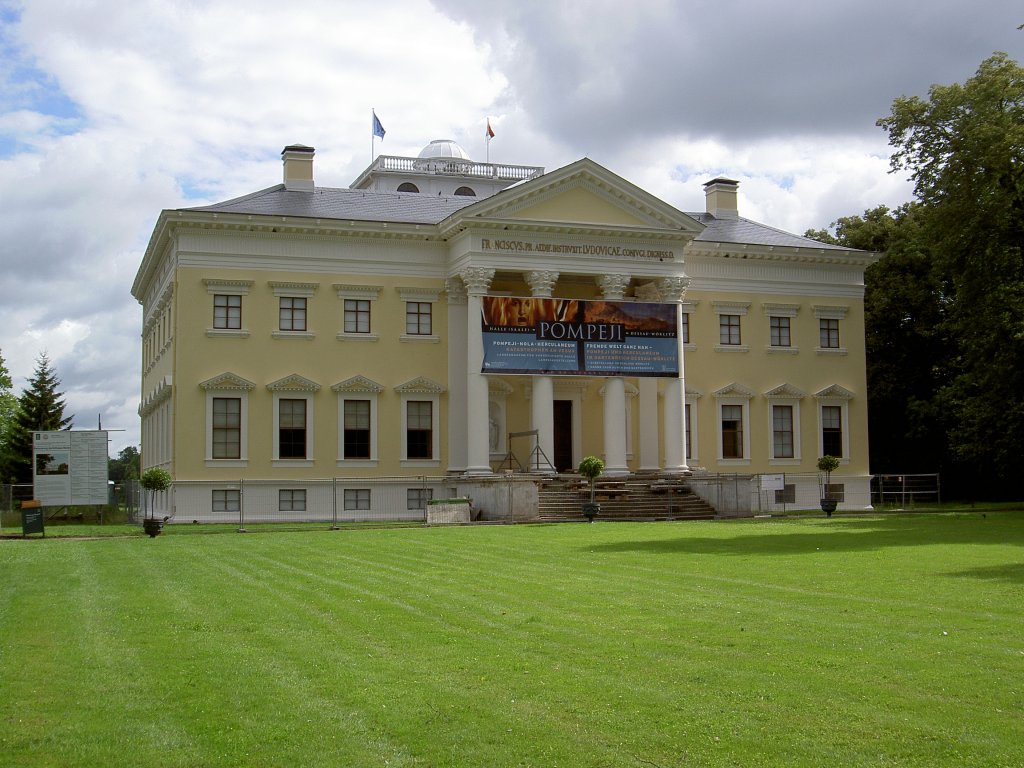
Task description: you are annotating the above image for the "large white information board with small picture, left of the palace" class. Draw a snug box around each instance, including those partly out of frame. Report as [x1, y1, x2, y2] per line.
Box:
[32, 430, 109, 507]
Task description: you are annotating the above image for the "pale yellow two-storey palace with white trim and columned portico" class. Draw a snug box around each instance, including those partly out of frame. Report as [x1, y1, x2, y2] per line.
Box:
[132, 140, 877, 520]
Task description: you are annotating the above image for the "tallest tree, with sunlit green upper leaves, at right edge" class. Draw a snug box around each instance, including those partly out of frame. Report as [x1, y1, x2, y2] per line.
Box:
[876, 53, 1024, 493]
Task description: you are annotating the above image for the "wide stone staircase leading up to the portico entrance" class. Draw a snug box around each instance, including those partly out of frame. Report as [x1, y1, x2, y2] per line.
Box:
[538, 475, 716, 522]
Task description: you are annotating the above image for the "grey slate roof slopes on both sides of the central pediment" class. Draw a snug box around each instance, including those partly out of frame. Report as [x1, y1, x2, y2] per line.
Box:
[184, 184, 849, 251]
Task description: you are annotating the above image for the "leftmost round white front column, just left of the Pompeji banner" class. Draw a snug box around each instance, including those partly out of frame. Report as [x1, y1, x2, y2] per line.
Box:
[459, 267, 495, 475]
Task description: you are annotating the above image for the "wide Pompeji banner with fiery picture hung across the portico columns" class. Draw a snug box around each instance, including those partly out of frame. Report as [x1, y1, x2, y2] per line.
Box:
[480, 296, 679, 377]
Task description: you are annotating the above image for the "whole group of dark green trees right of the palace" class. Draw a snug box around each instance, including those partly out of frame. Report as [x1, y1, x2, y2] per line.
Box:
[807, 53, 1024, 499]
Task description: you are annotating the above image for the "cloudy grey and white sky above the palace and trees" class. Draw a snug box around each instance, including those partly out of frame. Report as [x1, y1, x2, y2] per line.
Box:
[0, 0, 1024, 454]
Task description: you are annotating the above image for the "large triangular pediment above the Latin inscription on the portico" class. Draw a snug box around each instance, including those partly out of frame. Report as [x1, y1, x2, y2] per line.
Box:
[441, 158, 703, 237]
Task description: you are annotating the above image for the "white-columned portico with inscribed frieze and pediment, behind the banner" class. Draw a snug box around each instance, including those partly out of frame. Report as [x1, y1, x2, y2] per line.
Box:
[442, 160, 701, 477]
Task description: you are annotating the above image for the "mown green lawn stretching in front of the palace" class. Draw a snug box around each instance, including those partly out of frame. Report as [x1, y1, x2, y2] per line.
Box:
[0, 512, 1024, 768]
